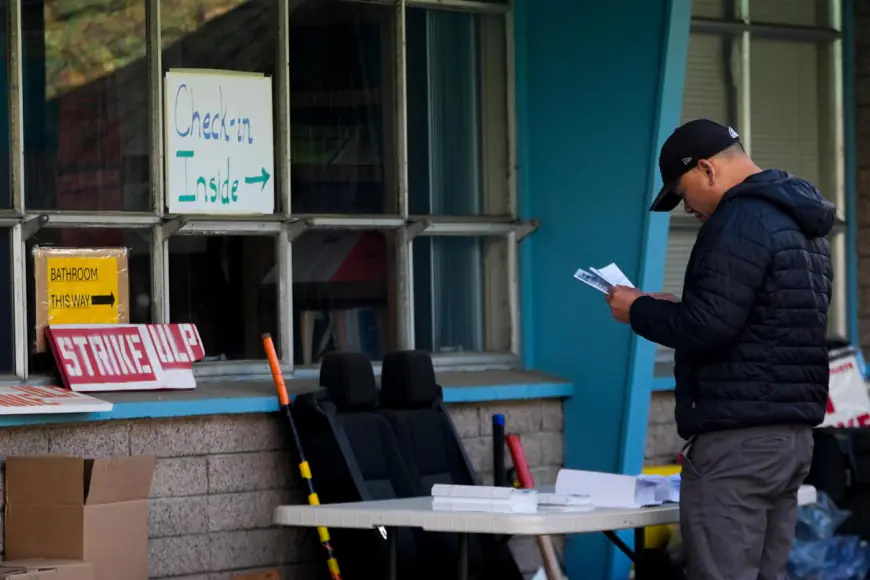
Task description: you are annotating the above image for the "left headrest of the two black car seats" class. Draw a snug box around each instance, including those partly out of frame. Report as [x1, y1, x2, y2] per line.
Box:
[320, 352, 378, 411]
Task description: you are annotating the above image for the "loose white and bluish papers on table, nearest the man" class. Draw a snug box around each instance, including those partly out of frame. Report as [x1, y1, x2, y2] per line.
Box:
[556, 469, 680, 508]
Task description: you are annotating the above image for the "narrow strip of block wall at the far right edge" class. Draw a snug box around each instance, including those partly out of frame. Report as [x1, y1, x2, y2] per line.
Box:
[851, 1, 870, 354]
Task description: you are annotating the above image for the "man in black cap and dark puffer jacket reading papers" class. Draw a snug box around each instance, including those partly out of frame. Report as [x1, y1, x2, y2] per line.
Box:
[607, 119, 835, 580]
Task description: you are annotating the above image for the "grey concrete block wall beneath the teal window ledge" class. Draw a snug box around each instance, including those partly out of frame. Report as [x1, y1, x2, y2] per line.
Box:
[0, 401, 563, 580]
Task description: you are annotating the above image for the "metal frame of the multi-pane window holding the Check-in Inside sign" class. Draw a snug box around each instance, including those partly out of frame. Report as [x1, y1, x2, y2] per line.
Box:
[0, 0, 537, 380]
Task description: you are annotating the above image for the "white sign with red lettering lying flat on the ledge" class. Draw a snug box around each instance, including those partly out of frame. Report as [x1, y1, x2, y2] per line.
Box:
[0, 385, 112, 415]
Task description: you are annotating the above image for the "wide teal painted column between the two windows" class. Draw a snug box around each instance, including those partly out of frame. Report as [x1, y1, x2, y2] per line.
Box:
[508, 0, 690, 579]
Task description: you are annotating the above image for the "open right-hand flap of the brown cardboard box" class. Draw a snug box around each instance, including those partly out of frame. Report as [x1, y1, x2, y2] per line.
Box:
[85, 456, 157, 505]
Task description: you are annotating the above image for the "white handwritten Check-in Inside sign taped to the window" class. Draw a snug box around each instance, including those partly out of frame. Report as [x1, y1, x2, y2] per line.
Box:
[164, 70, 275, 215]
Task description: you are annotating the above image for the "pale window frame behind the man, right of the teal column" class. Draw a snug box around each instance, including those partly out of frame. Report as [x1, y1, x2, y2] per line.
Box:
[653, 0, 855, 377]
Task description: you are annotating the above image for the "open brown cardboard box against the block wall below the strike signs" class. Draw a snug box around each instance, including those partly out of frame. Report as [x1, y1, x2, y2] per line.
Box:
[5, 455, 155, 580]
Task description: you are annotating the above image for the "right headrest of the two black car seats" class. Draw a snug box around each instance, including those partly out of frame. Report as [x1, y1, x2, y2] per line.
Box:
[381, 350, 441, 409]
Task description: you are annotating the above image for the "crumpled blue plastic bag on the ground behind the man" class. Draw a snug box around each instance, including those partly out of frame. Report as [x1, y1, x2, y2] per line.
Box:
[788, 492, 870, 580]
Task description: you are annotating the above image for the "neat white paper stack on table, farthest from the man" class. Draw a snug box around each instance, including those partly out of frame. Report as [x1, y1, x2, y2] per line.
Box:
[432, 483, 538, 514]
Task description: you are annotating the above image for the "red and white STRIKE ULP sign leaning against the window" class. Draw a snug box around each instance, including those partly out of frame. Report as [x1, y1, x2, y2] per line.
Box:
[46, 324, 205, 391]
